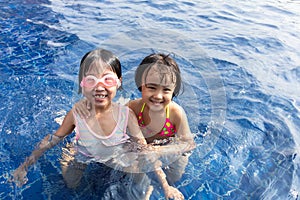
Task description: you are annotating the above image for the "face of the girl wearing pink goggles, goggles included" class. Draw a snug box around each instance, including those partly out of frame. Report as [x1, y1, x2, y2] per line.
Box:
[81, 69, 120, 109]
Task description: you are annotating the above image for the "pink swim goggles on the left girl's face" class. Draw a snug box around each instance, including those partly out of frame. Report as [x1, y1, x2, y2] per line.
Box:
[80, 74, 121, 88]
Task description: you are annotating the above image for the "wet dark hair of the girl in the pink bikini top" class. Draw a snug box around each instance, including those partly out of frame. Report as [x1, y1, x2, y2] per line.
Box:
[135, 53, 182, 97]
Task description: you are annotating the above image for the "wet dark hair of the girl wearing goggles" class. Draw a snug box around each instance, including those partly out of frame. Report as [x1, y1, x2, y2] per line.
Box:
[78, 49, 122, 94]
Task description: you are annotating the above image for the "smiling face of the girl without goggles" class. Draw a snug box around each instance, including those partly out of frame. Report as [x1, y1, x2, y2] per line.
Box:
[142, 66, 176, 111]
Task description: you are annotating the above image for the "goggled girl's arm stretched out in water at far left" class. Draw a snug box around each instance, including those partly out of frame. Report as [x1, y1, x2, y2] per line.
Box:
[12, 112, 75, 187]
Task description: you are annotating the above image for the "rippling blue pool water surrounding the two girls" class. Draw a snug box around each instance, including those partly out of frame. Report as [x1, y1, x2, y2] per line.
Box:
[0, 0, 300, 200]
